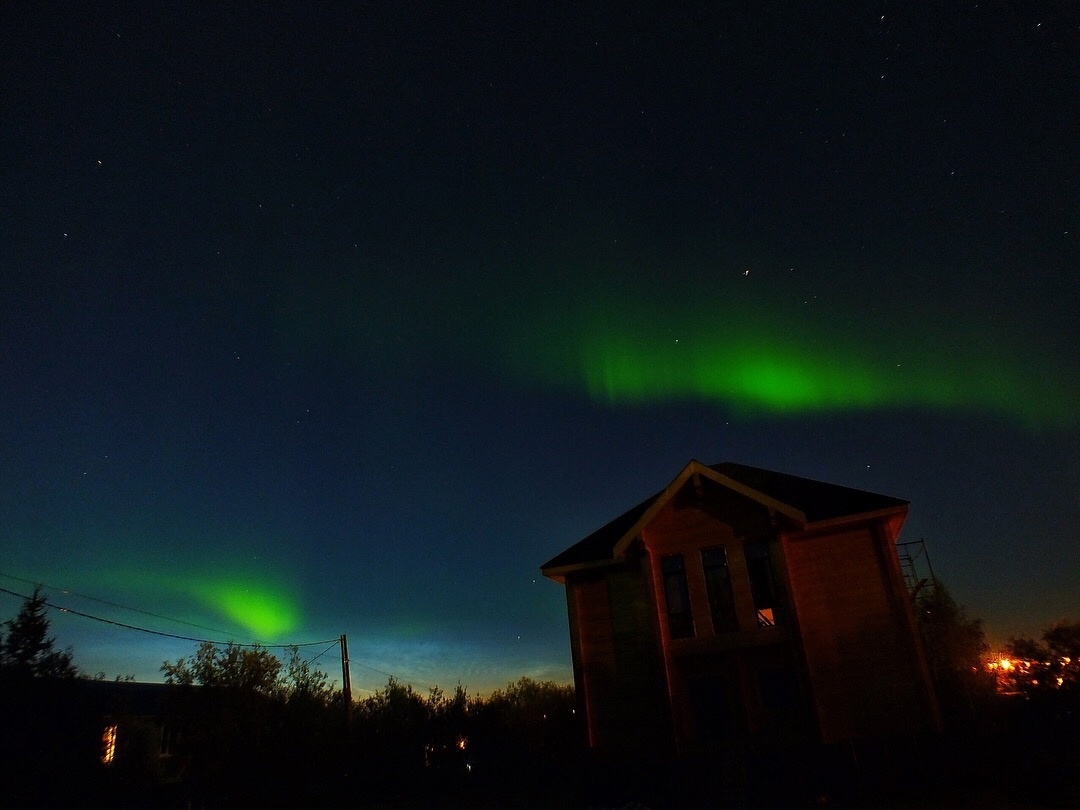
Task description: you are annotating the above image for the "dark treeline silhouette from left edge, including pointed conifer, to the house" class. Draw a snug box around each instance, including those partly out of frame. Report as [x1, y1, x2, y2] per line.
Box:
[0, 591, 580, 808]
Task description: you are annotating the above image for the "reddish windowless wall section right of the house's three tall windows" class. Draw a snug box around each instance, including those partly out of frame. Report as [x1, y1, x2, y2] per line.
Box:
[783, 524, 932, 742]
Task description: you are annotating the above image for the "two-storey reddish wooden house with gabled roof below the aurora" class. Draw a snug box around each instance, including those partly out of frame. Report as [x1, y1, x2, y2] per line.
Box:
[541, 461, 940, 753]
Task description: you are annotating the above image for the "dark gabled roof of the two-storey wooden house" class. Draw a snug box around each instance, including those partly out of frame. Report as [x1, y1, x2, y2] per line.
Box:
[540, 461, 908, 579]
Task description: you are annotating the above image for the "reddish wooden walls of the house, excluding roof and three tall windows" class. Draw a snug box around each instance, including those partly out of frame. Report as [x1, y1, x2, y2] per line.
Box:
[565, 480, 935, 753]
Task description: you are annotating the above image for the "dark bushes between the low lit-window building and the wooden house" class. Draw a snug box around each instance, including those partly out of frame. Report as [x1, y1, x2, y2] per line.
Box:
[162, 644, 579, 801]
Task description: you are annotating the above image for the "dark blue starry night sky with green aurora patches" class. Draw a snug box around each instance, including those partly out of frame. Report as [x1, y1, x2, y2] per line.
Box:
[0, 0, 1080, 694]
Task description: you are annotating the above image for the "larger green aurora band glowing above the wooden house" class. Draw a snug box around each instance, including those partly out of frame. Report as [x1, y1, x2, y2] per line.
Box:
[494, 282, 1080, 429]
